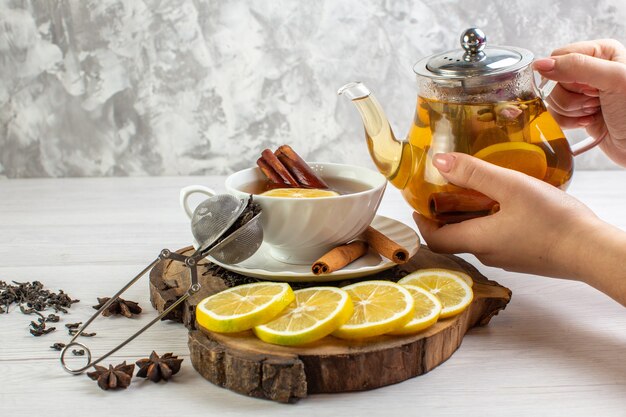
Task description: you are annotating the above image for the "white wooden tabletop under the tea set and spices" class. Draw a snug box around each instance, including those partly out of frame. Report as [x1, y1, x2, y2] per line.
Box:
[0, 171, 626, 417]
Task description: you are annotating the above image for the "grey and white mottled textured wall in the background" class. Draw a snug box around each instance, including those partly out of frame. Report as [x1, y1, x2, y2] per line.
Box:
[0, 0, 626, 178]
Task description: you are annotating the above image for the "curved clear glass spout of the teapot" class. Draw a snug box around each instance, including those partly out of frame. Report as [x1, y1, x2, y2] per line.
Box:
[337, 82, 410, 188]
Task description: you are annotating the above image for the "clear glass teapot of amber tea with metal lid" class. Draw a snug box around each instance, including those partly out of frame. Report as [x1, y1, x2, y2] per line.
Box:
[338, 28, 602, 224]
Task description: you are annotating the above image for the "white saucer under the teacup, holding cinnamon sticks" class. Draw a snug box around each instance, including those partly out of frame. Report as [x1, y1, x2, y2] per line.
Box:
[208, 216, 420, 282]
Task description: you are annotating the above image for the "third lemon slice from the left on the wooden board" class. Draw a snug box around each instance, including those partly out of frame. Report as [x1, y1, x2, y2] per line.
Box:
[332, 281, 415, 339]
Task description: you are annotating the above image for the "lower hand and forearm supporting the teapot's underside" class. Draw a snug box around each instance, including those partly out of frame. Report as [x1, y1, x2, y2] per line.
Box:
[413, 153, 626, 306]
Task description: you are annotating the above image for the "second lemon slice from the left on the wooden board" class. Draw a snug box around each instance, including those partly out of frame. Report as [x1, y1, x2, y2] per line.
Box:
[254, 287, 353, 346]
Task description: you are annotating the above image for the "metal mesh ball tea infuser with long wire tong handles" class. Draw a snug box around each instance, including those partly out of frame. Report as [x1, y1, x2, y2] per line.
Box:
[60, 194, 263, 375]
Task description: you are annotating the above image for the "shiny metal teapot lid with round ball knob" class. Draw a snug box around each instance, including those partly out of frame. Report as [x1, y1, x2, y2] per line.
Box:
[413, 28, 534, 80]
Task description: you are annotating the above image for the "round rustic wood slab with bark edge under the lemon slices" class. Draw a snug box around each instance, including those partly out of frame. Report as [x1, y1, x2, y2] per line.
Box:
[150, 246, 511, 402]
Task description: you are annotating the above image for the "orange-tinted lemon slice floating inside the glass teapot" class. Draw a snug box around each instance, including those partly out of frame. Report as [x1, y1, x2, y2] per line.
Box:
[474, 142, 548, 179]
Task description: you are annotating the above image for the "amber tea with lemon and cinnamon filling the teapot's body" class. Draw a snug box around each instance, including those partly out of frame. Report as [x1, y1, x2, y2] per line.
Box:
[399, 92, 573, 223]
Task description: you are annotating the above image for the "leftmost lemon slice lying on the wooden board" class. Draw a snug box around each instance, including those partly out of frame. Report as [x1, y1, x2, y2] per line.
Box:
[196, 282, 295, 333]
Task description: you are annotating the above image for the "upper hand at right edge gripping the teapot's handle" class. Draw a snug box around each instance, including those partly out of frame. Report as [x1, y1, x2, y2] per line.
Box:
[533, 39, 626, 166]
